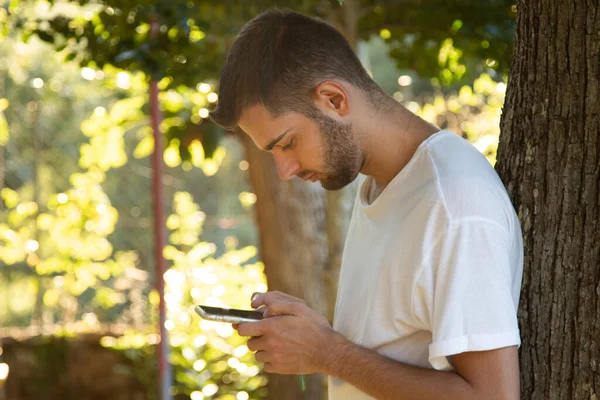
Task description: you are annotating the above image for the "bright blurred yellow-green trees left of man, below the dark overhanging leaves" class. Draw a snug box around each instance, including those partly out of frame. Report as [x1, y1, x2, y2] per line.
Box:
[0, 32, 266, 399]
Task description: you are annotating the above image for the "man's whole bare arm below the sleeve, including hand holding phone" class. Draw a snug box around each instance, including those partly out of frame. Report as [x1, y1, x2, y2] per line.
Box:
[236, 292, 519, 400]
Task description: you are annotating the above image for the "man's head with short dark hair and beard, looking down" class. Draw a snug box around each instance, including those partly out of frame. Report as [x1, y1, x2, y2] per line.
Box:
[211, 9, 384, 190]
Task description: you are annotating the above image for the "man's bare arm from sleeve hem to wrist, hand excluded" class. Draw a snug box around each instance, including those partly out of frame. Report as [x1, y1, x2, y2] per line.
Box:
[323, 339, 519, 400]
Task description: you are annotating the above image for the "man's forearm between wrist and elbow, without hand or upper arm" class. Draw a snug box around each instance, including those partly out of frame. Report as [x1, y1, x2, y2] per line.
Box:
[323, 336, 478, 400]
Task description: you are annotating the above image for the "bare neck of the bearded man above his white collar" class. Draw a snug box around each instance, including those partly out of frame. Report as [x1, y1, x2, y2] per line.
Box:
[360, 100, 440, 190]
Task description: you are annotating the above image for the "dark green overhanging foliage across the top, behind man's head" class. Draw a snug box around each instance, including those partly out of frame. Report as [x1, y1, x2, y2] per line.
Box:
[0, 0, 515, 166]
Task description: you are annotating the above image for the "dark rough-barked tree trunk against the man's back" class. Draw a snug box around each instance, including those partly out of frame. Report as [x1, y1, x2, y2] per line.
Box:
[497, 0, 600, 400]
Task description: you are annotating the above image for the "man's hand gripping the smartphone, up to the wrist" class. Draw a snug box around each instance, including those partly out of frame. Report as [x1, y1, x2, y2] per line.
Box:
[234, 292, 344, 374]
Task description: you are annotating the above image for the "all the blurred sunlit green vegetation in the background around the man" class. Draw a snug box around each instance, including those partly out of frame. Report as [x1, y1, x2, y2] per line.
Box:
[0, 0, 516, 400]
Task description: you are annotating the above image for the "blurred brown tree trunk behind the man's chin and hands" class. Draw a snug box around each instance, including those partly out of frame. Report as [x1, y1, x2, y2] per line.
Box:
[240, 0, 358, 400]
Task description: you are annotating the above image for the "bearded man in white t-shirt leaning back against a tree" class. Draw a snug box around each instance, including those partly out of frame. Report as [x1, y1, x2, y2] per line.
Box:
[212, 10, 523, 400]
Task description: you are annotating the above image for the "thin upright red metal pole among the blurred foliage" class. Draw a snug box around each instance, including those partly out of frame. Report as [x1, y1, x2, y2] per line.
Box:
[150, 17, 171, 400]
